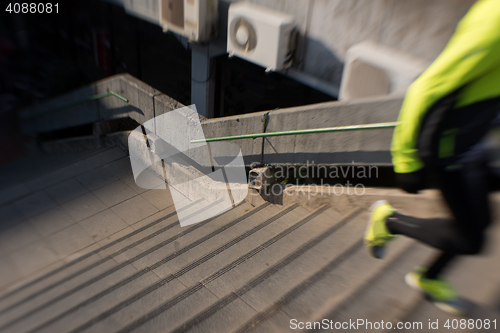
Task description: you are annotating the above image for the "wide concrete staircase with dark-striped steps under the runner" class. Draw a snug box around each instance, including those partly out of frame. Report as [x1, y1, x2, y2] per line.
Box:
[0, 150, 500, 333]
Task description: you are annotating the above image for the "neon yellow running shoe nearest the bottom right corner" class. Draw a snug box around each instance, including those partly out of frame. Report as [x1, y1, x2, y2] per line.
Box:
[405, 267, 467, 316]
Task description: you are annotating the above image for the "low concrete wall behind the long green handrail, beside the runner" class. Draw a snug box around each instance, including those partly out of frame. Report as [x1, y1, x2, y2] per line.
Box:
[202, 97, 402, 166]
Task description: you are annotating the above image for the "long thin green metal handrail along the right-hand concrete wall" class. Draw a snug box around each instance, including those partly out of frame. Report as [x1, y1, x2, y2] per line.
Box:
[190, 122, 398, 143]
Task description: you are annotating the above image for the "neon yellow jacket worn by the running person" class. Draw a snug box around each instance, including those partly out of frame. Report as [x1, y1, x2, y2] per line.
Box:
[391, 0, 500, 173]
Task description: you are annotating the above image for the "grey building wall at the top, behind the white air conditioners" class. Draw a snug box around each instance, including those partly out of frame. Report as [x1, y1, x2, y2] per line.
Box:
[231, 0, 475, 86]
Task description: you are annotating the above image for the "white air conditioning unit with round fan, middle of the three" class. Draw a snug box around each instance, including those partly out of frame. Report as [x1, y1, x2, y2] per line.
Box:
[227, 2, 298, 71]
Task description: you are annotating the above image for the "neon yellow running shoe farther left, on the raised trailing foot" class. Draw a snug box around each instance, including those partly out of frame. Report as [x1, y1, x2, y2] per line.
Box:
[364, 200, 396, 259]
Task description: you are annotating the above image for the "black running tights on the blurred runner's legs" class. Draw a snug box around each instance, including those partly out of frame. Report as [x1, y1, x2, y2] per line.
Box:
[387, 159, 491, 278]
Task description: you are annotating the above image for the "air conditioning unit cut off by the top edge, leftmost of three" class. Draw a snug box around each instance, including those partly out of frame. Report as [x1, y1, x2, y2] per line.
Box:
[159, 0, 219, 42]
